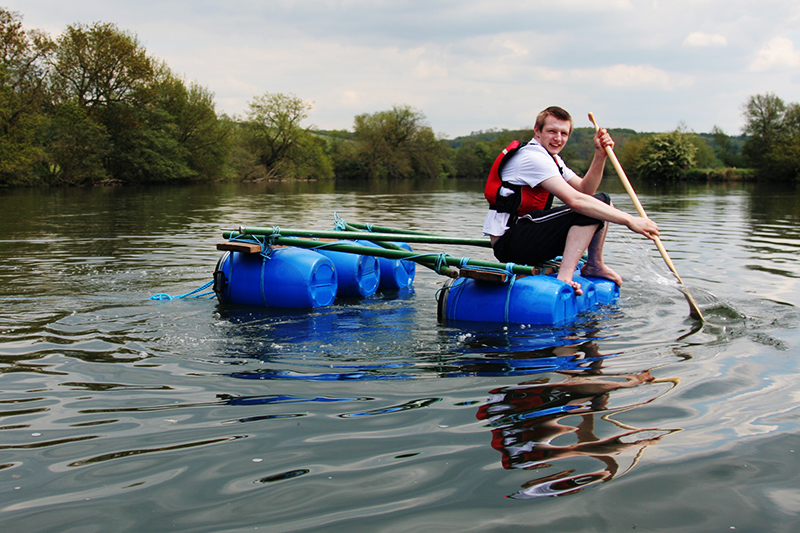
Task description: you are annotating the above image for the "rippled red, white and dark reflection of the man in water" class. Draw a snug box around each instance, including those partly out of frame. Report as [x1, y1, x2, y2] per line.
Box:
[477, 367, 672, 498]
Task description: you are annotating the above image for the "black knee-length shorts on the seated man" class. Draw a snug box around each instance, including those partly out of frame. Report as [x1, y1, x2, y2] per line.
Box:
[494, 192, 611, 265]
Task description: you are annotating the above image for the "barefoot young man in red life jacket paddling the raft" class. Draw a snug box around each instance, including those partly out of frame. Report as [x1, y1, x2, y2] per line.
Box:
[483, 106, 658, 295]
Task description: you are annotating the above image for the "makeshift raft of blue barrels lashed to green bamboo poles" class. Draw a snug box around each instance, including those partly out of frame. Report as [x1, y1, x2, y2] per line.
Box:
[208, 221, 619, 326]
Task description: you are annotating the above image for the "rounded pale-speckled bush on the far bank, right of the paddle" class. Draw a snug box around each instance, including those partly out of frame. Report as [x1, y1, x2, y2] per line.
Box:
[634, 130, 697, 180]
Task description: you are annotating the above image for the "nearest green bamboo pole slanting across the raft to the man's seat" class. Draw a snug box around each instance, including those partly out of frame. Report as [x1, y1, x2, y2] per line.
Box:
[223, 230, 536, 275]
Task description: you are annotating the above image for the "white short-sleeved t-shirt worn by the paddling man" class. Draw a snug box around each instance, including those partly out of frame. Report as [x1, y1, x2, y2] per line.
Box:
[483, 140, 577, 237]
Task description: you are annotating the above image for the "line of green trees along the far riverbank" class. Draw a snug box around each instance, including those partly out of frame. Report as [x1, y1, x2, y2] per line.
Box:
[0, 8, 800, 186]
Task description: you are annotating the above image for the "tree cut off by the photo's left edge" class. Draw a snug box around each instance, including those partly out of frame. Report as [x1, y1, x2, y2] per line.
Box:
[0, 8, 55, 185]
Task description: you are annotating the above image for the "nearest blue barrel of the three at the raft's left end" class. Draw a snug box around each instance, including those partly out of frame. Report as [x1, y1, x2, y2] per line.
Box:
[214, 248, 338, 308]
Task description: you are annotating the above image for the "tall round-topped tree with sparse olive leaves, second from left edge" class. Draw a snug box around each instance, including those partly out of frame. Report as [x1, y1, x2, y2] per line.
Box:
[47, 23, 161, 182]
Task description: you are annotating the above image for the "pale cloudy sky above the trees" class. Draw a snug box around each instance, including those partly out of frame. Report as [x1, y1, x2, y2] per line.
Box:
[6, 0, 800, 139]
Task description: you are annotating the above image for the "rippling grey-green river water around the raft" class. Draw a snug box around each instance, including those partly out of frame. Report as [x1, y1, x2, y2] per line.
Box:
[0, 178, 800, 532]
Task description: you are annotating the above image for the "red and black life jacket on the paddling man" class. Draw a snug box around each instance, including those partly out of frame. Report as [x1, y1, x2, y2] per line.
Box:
[483, 141, 561, 217]
